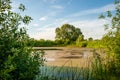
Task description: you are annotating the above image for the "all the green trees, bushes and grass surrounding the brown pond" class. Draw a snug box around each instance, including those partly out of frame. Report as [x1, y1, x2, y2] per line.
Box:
[0, 0, 120, 80]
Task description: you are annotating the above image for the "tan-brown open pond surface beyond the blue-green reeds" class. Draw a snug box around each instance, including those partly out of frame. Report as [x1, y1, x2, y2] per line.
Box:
[41, 47, 92, 67]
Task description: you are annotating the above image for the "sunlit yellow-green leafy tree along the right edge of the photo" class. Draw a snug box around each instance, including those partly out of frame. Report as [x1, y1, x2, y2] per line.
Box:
[99, 0, 120, 75]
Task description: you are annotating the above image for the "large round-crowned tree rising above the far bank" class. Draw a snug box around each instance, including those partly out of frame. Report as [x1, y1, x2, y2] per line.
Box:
[55, 24, 82, 44]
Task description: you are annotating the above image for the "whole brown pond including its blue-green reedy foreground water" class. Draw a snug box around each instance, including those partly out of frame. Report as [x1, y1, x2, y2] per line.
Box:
[36, 47, 93, 80]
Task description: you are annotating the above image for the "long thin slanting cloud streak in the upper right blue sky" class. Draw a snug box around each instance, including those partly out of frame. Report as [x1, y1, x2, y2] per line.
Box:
[70, 4, 115, 17]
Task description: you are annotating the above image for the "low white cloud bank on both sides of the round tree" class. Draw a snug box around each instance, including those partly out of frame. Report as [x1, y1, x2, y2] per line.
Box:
[32, 19, 107, 40]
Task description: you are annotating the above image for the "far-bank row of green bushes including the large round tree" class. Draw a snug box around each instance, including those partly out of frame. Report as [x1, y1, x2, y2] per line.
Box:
[28, 24, 93, 47]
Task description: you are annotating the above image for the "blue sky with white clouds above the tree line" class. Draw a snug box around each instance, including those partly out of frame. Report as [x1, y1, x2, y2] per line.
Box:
[12, 0, 115, 40]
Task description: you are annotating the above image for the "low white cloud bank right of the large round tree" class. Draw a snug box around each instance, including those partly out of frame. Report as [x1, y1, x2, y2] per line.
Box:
[71, 19, 108, 39]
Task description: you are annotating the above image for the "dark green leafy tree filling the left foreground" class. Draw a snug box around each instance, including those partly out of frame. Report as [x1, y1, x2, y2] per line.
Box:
[0, 0, 44, 80]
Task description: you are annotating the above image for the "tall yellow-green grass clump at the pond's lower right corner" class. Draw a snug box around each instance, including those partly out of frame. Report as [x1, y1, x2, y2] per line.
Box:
[91, 51, 120, 80]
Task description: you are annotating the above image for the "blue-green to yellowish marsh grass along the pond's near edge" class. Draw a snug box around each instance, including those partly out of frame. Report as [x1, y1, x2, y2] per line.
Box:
[36, 50, 120, 80]
